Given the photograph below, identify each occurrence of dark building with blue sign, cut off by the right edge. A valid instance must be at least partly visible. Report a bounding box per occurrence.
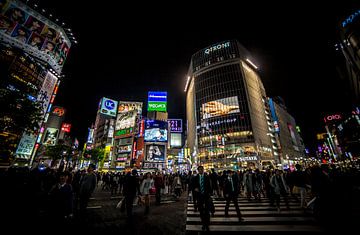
[335,8,360,105]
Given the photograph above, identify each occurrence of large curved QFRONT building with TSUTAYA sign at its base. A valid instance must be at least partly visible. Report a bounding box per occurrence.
[185,40,276,169]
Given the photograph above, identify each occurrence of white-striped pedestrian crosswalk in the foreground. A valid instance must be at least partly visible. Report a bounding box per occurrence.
[186,197,322,234]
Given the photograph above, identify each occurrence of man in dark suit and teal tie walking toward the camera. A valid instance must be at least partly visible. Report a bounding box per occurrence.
[193,166,212,231]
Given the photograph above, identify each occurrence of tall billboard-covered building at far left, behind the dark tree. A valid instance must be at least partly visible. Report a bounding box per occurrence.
[0,0,74,164]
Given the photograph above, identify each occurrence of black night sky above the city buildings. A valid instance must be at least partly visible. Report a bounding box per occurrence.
[33,0,358,151]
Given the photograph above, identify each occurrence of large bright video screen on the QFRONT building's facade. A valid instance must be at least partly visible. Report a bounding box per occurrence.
[202,96,240,119]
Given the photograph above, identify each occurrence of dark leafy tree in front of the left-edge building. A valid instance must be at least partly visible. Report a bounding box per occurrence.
[0,87,44,165]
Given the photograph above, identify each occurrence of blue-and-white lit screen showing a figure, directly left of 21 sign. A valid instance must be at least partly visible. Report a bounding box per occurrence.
[144,120,168,142]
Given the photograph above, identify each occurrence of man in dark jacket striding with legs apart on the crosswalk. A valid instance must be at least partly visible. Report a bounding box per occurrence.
[224,170,244,222]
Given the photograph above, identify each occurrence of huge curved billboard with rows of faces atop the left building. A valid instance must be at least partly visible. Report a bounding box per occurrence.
[0,0,71,74]
